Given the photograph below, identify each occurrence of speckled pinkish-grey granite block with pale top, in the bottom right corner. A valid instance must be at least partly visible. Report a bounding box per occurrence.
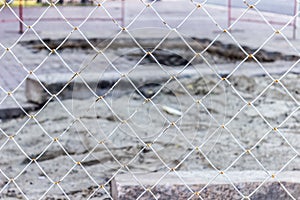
[111,171,300,200]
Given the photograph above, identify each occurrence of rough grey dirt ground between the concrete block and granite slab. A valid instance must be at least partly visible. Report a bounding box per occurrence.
[0,60,300,199]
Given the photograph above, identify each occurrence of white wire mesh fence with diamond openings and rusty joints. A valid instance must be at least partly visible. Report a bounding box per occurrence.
[0,0,300,199]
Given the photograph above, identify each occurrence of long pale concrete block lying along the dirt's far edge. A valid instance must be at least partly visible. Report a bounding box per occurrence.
[25,68,195,104]
